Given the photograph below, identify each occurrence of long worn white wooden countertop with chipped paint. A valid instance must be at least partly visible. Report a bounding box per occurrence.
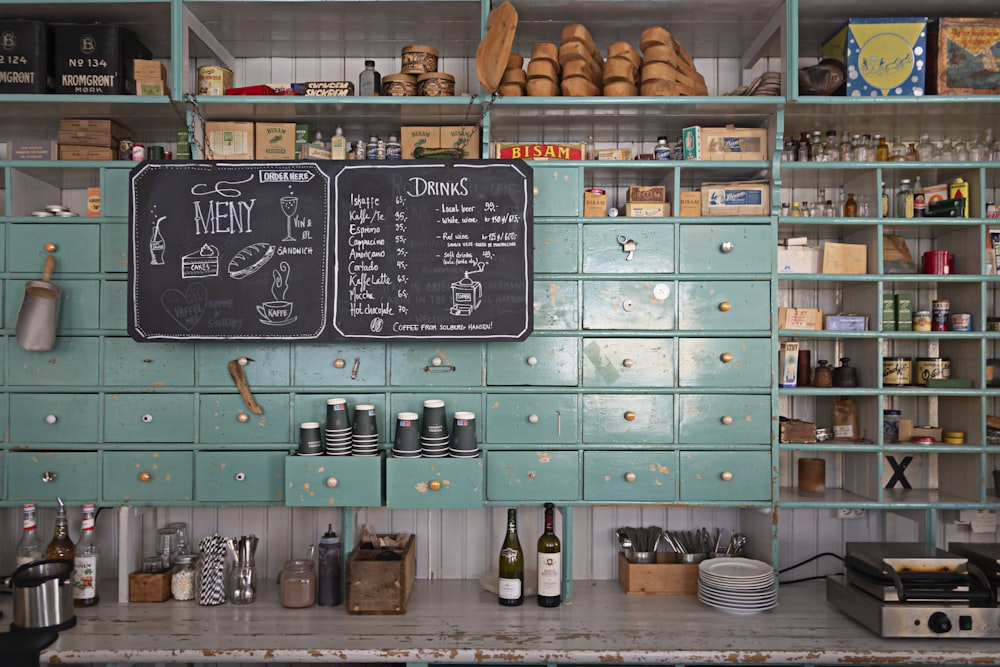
[7,581,1000,665]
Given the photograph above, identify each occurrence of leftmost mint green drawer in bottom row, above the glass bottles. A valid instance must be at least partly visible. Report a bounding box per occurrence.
[6,452,101,503]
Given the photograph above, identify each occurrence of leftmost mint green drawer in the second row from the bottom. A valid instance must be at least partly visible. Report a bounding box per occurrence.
[10,394,100,445]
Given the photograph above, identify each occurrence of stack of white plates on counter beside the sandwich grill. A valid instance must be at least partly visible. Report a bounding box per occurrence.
[698,558,778,614]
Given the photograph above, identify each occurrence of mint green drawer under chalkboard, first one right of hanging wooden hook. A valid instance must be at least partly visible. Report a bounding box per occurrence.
[292,343,385,389]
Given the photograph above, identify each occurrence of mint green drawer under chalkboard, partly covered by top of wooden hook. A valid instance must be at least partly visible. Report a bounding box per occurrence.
[195,342,292,390]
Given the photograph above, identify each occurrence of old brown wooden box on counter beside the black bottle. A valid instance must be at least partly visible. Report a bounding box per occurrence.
[346,535,416,614]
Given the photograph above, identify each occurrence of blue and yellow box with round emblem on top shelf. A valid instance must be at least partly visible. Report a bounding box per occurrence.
[822,17,927,97]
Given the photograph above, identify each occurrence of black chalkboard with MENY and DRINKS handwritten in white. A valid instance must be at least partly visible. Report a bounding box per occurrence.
[129,160,533,341]
